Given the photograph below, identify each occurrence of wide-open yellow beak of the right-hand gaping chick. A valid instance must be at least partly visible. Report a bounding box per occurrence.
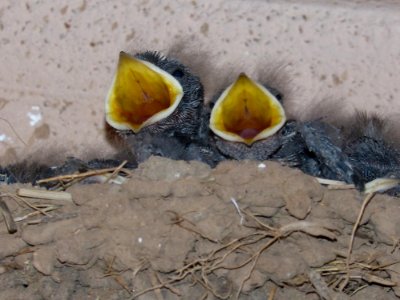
[210,73,286,145]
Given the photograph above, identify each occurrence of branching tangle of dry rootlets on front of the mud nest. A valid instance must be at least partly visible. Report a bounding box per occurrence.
[130,203,336,299]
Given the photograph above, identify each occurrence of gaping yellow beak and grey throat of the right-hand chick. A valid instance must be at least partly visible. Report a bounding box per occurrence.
[209,73,286,160]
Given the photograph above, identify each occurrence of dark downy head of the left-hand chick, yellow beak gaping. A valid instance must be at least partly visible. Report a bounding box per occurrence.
[105,51,203,135]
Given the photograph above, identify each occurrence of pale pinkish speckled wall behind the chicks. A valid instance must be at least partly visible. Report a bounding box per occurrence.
[0,0,400,162]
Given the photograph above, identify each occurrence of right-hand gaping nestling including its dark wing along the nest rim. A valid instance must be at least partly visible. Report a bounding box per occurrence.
[206,74,372,189]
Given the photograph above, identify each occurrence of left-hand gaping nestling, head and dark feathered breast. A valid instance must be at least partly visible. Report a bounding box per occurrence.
[105,51,222,165]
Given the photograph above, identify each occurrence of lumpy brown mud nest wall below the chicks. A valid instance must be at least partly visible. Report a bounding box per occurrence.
[0,158,400,299]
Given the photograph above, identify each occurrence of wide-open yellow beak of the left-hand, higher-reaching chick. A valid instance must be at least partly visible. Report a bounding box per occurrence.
[106,52,183,133]
